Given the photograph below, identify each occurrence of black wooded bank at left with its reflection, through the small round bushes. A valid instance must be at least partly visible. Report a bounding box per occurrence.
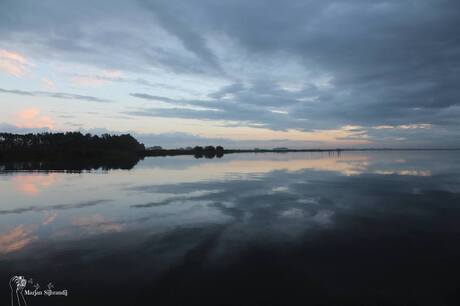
[0,132,224,172]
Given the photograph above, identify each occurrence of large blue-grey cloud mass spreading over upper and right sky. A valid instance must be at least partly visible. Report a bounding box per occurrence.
[0,0,460,145]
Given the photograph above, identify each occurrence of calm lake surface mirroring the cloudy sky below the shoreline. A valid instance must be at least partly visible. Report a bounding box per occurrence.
[0,151,460,306]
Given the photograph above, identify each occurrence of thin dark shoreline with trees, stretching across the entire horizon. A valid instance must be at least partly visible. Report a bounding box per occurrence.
[0,132,460,167]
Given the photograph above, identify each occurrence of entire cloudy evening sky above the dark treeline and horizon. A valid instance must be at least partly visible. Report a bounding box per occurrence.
[0,0,460,148]
